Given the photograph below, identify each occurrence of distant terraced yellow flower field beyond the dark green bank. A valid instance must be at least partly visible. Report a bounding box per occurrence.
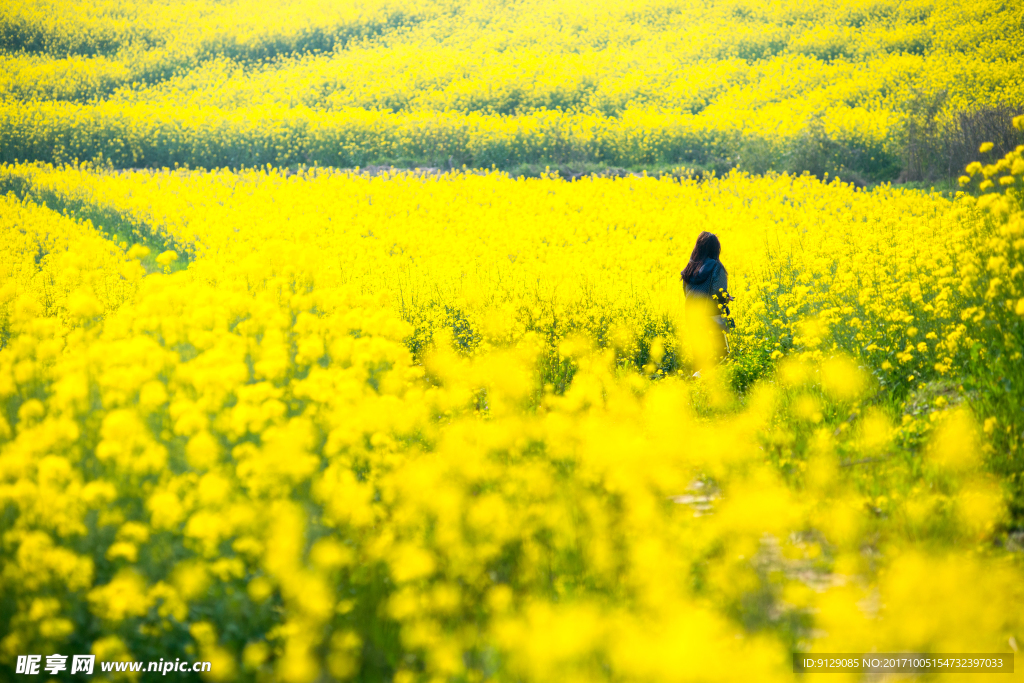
[0,0,1024,182]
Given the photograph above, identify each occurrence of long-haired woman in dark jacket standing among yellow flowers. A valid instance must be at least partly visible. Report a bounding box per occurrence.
[679,231,733,377]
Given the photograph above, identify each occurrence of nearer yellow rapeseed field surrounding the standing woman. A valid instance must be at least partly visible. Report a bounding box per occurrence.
[0,131,1024,683]
